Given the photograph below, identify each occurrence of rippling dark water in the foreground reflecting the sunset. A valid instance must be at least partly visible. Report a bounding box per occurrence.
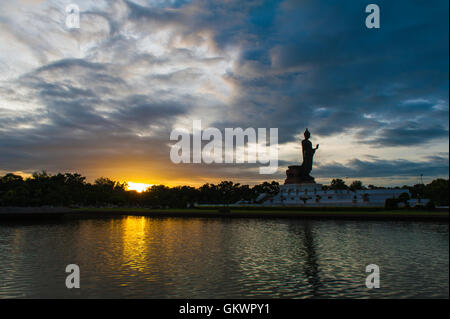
[0,217,449,298]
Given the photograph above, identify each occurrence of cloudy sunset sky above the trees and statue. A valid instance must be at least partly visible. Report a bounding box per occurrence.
[0,0,449,186]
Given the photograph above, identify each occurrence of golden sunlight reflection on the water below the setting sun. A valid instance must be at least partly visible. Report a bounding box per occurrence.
[116,216,226,295]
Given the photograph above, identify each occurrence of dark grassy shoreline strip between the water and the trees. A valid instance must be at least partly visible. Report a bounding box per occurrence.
[0,207,449,221]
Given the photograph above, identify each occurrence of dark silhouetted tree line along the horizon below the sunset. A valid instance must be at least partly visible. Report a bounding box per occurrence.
[0,171,449,208]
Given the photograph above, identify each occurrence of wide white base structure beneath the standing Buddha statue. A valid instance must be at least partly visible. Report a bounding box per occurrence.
[262,183,416,206]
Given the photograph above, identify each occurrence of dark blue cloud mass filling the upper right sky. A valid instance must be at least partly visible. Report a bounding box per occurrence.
[215,1,448,145]
